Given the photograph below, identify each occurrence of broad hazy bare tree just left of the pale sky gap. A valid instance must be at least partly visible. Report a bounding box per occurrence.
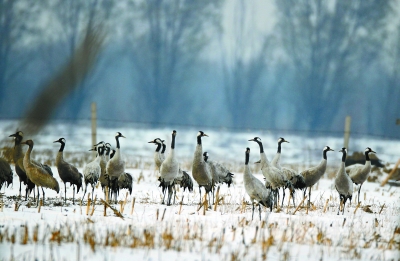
[127,0,221,123]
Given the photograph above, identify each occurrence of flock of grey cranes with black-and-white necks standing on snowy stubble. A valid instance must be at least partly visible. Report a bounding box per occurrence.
[0,130,375,219]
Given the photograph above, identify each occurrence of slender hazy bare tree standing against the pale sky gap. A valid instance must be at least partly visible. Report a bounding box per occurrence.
[220,0,274,128]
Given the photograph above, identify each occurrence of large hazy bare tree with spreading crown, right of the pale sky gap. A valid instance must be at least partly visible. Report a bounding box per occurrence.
[276,0,390,129]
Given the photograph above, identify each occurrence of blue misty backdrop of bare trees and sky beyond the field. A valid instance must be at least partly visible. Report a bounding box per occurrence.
[0,0,400,138]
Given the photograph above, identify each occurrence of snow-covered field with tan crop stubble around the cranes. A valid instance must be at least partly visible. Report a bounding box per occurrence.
[0,121,400,260]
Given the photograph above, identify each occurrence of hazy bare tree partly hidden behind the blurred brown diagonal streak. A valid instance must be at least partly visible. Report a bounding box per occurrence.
[43,0,113,118]
